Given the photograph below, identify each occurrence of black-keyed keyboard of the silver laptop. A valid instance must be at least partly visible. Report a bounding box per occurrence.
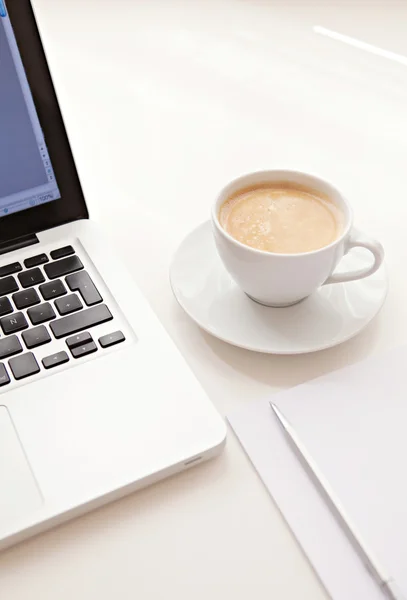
[0,246,125,387]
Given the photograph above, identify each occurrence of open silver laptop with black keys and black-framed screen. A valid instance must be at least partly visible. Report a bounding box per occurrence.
[0,0,226,549]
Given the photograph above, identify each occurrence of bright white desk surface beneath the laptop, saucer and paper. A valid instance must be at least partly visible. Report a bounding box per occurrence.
[0,0,407,600]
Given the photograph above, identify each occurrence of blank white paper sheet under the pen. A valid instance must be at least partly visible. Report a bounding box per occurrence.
[229,347,407,600]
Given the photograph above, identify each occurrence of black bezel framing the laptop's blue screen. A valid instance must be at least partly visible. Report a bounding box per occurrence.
[0,0,89,243]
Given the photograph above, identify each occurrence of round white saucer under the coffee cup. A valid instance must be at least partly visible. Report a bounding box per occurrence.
[170,222,388,354]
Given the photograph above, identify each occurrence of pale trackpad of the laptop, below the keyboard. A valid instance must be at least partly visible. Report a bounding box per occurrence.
[0,406,42,530]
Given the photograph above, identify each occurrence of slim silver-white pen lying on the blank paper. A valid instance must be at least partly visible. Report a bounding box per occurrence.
[270,402,404,600]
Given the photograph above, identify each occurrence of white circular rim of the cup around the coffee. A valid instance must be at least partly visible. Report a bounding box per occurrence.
[211,168,353,258]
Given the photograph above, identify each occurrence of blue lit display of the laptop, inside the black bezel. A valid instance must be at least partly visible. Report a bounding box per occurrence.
[0,0,61,217]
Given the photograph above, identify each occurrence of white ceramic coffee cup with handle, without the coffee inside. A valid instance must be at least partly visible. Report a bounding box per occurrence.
[212,170,384,306]
